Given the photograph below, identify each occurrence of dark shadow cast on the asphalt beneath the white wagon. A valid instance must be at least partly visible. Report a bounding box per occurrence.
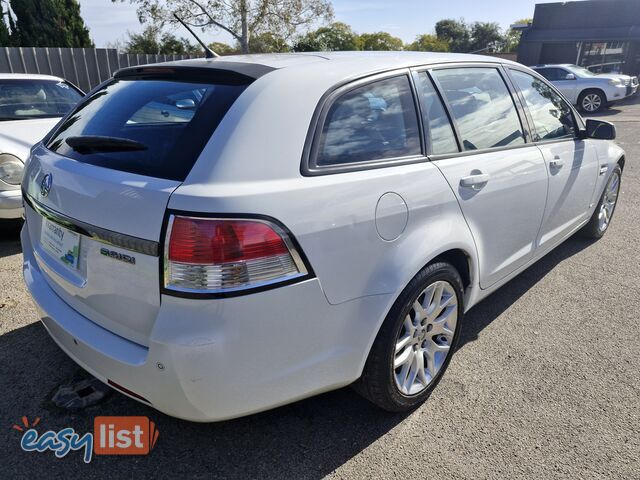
[0,232,590,479]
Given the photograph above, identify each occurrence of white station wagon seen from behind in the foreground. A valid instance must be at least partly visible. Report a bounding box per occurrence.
[22,53,625,421]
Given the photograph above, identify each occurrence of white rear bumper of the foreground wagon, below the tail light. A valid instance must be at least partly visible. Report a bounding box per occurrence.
[22,226,392,422]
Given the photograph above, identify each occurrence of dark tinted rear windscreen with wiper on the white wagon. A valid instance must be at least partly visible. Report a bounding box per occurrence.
[47,78,247,181]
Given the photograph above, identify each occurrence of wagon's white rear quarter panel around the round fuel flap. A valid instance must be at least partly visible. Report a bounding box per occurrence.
[170,161,476,304]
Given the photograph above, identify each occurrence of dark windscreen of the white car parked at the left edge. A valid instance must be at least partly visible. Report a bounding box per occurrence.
[0,79,82,120]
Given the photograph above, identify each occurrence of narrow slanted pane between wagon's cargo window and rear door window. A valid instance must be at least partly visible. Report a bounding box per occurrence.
[418,72,458,155]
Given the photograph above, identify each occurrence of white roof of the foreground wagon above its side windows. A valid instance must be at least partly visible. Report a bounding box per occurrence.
[132,51,516,78]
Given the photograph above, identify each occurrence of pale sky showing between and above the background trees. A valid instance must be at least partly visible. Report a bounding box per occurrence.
[79,0,557,47]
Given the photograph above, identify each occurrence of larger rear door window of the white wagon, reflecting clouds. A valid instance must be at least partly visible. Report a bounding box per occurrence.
[433,68,524,150]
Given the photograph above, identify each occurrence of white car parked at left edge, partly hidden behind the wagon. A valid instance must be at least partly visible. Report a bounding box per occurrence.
[0,73,83,219]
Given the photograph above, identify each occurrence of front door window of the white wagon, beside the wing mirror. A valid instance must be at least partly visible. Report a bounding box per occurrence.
[511,70,576,141]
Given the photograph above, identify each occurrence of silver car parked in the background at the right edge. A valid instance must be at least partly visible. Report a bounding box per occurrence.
[532,64,638,113]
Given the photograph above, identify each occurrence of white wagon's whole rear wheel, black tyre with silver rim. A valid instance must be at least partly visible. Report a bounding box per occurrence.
[354,262,464,412]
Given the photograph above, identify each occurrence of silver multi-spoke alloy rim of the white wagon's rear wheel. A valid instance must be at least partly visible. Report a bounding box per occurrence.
[393,281,458,395]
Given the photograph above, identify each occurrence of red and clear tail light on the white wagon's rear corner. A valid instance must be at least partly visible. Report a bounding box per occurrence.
[164,215,308,294]
